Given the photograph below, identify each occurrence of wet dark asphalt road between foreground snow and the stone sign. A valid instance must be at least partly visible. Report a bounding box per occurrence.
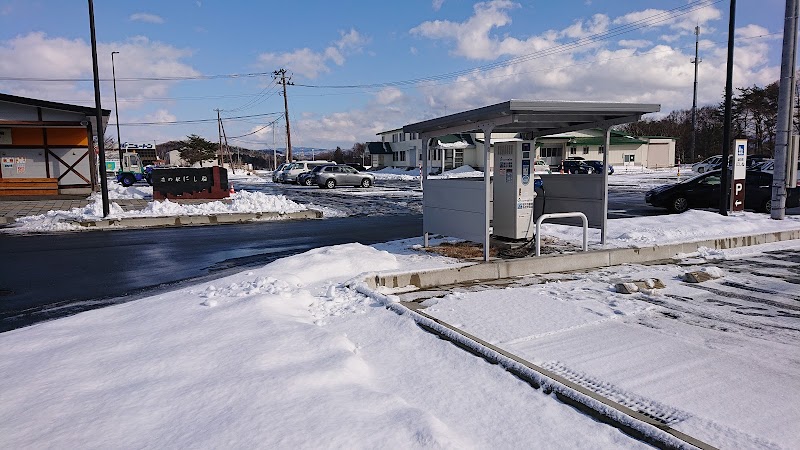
[0,215,422,332]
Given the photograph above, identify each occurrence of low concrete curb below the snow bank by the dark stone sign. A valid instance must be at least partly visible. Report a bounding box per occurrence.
[72,209,322,229]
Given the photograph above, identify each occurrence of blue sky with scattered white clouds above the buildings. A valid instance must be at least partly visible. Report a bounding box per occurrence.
[0,0,785,148]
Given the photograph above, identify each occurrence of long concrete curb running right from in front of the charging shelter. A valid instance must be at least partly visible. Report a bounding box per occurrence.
[364,229,800,289]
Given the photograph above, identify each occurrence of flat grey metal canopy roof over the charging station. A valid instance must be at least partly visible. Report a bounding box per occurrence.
[403,100,661,138]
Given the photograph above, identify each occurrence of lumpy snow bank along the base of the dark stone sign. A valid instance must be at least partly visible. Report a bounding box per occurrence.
[6,191,308,233]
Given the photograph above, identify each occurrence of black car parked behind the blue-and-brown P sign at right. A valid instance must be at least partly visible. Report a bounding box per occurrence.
[644,170,800,213]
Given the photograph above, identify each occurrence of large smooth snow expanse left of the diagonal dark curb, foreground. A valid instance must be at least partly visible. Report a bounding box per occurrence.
[0,244,646,448]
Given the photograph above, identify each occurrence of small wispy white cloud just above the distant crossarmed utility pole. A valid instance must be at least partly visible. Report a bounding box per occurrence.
[258,28,369,79]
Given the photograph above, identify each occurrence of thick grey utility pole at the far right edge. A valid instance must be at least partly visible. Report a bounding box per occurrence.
[770,0,798,220]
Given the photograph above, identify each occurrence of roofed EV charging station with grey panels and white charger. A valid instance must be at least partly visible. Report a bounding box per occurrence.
[403,100,661,261]
